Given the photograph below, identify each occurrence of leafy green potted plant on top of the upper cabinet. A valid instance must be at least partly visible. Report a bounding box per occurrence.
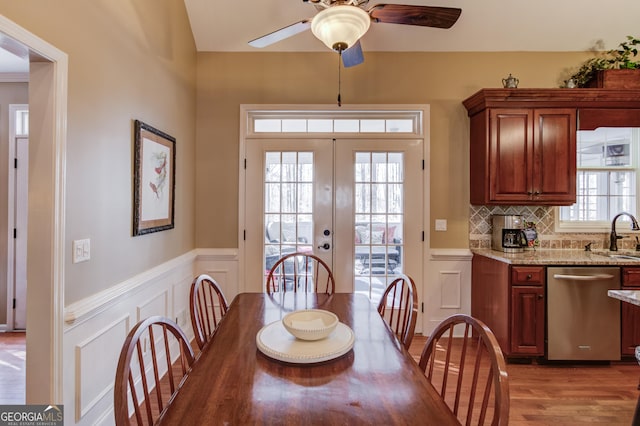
[570,36,640,89]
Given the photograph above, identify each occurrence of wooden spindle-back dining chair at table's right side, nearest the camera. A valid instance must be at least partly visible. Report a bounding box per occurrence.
[419,314,509,426]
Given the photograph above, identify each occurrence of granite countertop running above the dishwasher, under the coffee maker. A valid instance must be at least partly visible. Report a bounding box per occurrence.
[471,249,640,266]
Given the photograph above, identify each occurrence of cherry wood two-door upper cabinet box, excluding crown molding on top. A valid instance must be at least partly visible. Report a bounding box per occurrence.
[465,89,576,205]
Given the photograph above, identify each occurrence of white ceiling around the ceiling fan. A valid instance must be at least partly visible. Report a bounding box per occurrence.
[185,0,640,52]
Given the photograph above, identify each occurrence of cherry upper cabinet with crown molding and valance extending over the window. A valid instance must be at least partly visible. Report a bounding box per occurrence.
[463,89,640,206]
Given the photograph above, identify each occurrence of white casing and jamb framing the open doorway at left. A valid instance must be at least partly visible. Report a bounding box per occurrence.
[0,15,68,404]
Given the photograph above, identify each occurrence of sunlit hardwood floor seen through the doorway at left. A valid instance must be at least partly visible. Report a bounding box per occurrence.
[0,333,26,404]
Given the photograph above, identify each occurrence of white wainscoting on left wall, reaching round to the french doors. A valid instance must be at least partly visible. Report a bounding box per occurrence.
[63,249,240,425]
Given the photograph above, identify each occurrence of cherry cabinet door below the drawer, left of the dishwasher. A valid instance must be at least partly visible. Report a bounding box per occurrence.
[511,286,544,355]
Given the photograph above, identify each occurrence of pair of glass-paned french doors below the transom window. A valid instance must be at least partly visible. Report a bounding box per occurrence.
[244,138,424,303]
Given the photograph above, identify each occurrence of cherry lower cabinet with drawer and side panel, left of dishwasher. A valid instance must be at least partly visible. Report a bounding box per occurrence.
[471,255,545,357]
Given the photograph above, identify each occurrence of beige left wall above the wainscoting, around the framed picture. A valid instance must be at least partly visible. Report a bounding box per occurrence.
[0,0,196,304]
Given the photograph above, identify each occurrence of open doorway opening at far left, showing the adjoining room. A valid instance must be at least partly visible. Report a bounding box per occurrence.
[0,65,29,404]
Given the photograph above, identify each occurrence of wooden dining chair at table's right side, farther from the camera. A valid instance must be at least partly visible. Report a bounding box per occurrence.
[378,275,418,350]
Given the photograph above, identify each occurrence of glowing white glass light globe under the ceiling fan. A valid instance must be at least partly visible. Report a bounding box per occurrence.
[311,5,371,49]
